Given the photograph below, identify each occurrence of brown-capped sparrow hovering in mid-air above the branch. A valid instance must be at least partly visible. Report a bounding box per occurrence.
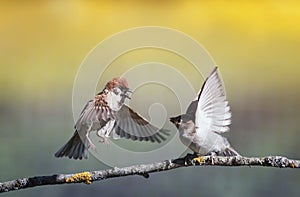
[55,78,168,159]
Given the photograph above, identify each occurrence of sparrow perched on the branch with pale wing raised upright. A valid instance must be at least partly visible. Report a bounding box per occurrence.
[170,67,239,156]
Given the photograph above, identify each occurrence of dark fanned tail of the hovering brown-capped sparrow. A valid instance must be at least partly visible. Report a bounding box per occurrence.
[54,131,88,159]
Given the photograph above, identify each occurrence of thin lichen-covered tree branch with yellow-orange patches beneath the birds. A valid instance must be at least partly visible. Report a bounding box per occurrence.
[0,155,300,193]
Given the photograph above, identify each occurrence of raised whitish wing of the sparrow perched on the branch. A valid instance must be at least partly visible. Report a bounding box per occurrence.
[193,67,231,133]
